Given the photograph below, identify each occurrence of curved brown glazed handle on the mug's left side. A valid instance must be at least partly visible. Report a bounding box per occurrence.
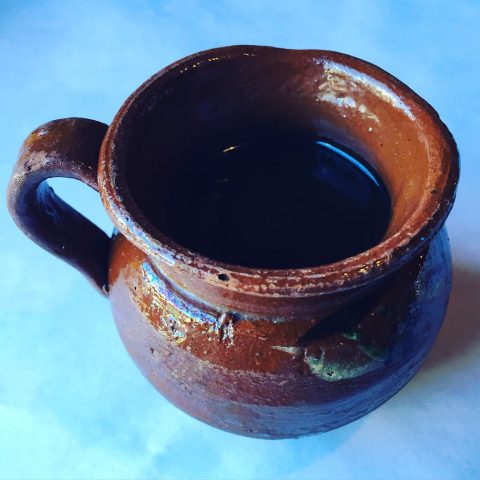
[7,118,110,295]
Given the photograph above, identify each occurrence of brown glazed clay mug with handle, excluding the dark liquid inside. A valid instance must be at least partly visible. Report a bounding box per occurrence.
[8,46,459,438]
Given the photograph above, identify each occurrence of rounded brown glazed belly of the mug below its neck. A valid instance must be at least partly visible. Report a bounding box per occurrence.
[110,229,451,438]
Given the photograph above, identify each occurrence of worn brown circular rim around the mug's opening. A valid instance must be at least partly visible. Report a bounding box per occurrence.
[98,45,459,297]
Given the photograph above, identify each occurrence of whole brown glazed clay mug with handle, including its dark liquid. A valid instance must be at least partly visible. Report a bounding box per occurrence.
[8,46,459,438]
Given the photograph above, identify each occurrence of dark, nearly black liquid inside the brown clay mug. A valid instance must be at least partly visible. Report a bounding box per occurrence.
[159,138,390,269]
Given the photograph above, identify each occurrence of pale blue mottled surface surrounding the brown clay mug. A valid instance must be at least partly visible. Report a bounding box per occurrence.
[0,0,480,479]
